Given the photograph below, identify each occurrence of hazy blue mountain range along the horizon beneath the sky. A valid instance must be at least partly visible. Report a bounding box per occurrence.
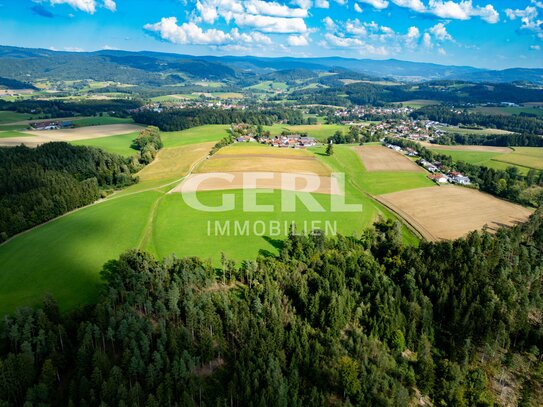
[0,46,543,85]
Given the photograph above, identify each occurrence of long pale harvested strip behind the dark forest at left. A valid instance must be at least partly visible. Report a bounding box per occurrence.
[0,124,143,147]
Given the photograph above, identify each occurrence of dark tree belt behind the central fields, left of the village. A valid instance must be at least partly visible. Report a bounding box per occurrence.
[132,108,305,131]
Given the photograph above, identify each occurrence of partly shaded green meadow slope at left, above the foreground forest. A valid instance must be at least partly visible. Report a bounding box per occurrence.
[0,192,159,315]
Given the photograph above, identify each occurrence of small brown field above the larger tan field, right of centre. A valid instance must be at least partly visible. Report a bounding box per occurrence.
[354,146,424,172]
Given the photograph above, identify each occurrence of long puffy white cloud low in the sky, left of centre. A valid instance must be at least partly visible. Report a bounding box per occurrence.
[144,17,272,45]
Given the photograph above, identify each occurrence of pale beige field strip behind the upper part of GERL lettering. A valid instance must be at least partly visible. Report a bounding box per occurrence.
[170,172,342,195]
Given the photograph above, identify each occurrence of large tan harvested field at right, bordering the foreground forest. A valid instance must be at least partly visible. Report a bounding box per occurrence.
[376,186,532,241]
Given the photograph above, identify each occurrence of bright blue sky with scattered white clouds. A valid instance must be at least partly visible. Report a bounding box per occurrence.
[0,0,543,69]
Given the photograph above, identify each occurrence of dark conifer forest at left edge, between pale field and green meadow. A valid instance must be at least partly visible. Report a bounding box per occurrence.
[0,142,138,242]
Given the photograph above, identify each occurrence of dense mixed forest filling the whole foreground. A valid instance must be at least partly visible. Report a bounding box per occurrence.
[0,211,543,407]
